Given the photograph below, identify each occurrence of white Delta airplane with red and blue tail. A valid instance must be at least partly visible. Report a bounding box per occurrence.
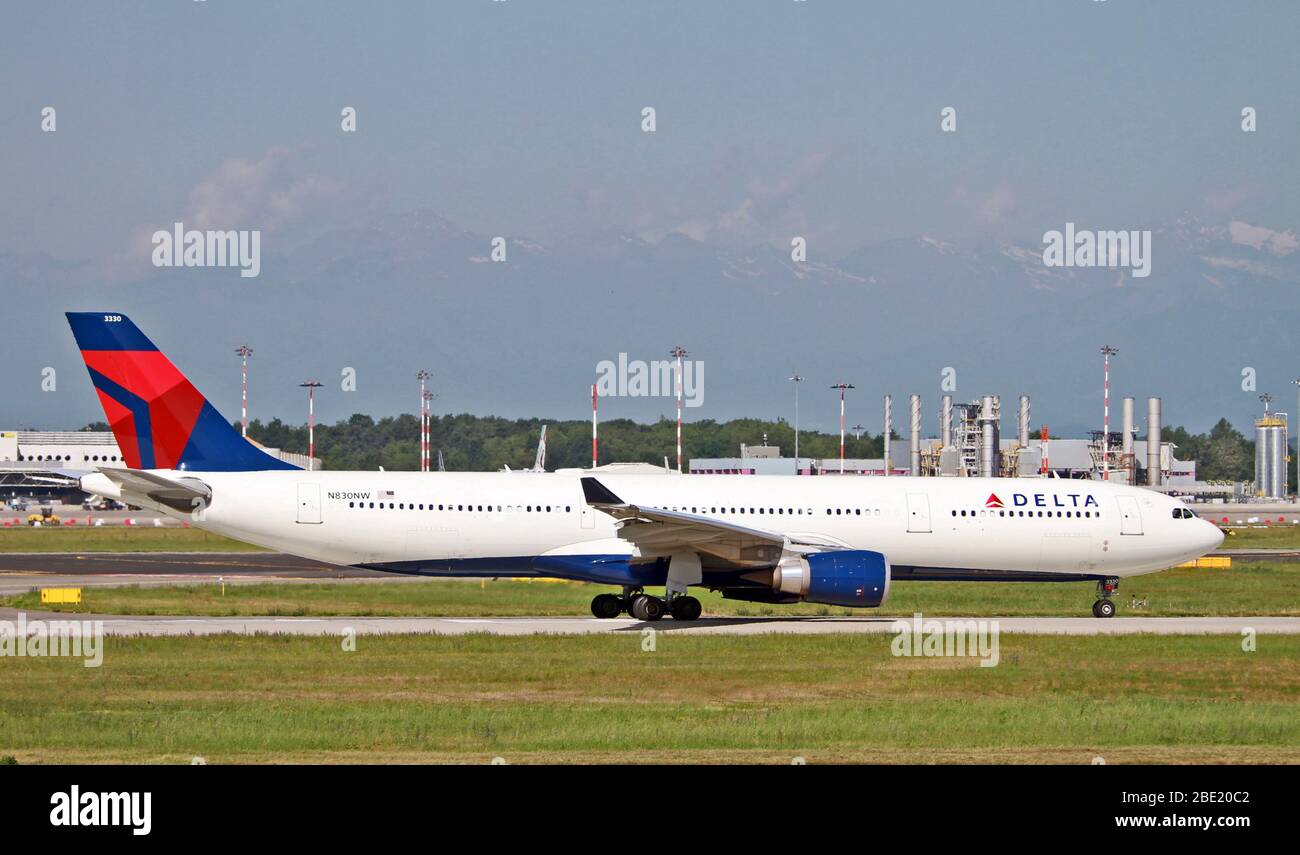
[68,312,1223,621]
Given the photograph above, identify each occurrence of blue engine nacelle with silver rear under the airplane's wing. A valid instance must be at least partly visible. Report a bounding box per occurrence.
[772,550,889,608]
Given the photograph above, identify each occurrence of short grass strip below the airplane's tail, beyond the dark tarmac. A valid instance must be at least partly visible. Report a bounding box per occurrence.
[0,525,263,552]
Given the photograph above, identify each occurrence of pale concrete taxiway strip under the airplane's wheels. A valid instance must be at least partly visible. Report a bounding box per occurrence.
[0,608,1300,637]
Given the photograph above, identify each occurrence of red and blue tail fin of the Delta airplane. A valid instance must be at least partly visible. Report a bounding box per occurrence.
[68,312,295,472]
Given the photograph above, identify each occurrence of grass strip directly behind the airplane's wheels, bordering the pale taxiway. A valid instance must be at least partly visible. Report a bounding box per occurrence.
[10,561,1300,617]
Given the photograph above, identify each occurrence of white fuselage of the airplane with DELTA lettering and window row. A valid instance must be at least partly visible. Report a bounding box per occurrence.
[83,472,1222,577]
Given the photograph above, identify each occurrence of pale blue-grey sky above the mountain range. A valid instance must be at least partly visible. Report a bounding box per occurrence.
[0,0,1300,436]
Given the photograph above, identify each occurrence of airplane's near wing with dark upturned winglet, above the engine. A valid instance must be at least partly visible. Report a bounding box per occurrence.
[582,477,844,568]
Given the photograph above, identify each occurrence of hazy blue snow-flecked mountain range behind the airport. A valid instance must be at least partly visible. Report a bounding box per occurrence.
[0,209,1300,434]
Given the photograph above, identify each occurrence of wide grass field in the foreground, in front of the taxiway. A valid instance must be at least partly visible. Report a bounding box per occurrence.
[0,633,1300,764]
